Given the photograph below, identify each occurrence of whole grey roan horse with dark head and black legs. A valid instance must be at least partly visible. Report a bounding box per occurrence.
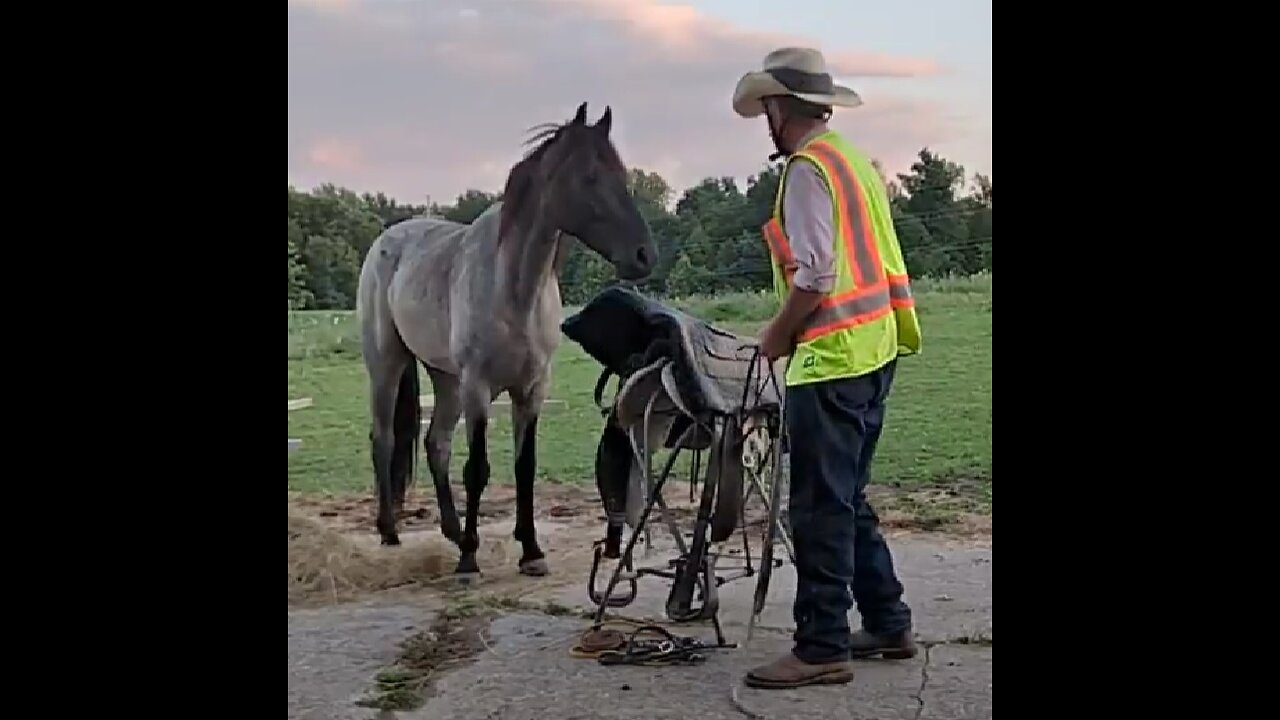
[356,102,658,575]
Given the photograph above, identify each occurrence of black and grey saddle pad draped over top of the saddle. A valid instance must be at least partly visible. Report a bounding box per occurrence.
[561,286,782,419]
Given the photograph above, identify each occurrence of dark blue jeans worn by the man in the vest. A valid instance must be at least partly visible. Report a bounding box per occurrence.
[786,360,911,662]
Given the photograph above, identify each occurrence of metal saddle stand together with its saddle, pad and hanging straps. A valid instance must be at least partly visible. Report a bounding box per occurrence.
[562,287,794,648]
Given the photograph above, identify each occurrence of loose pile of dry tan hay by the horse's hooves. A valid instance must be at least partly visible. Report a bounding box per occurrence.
[289,503,511,605]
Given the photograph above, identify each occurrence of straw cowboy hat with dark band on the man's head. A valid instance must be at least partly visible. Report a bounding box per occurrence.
[733,47,863,118]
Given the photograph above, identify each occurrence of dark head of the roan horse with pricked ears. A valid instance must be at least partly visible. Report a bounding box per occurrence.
[500,102,658,281]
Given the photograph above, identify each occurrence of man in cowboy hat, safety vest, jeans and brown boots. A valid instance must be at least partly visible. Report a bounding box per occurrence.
[733,47,920,688]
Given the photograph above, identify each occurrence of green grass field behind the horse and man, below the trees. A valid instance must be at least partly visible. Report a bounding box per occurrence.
[289,275,992,511]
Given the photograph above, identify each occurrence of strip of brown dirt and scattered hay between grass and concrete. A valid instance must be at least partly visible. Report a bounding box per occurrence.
[289,479,991,606]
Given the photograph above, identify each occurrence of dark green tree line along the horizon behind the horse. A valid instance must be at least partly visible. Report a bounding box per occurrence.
[289,149,991,310]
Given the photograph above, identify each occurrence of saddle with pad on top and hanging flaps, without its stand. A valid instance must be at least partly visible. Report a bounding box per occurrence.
[561,287,782,542]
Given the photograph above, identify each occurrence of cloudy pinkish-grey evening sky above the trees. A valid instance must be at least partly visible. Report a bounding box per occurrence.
[289,0,991,204]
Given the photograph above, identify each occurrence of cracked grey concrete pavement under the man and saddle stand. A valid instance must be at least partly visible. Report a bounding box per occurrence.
[289,536,992,720]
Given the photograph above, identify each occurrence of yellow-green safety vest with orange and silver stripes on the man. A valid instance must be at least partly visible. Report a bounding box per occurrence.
[763,131,922,386]
